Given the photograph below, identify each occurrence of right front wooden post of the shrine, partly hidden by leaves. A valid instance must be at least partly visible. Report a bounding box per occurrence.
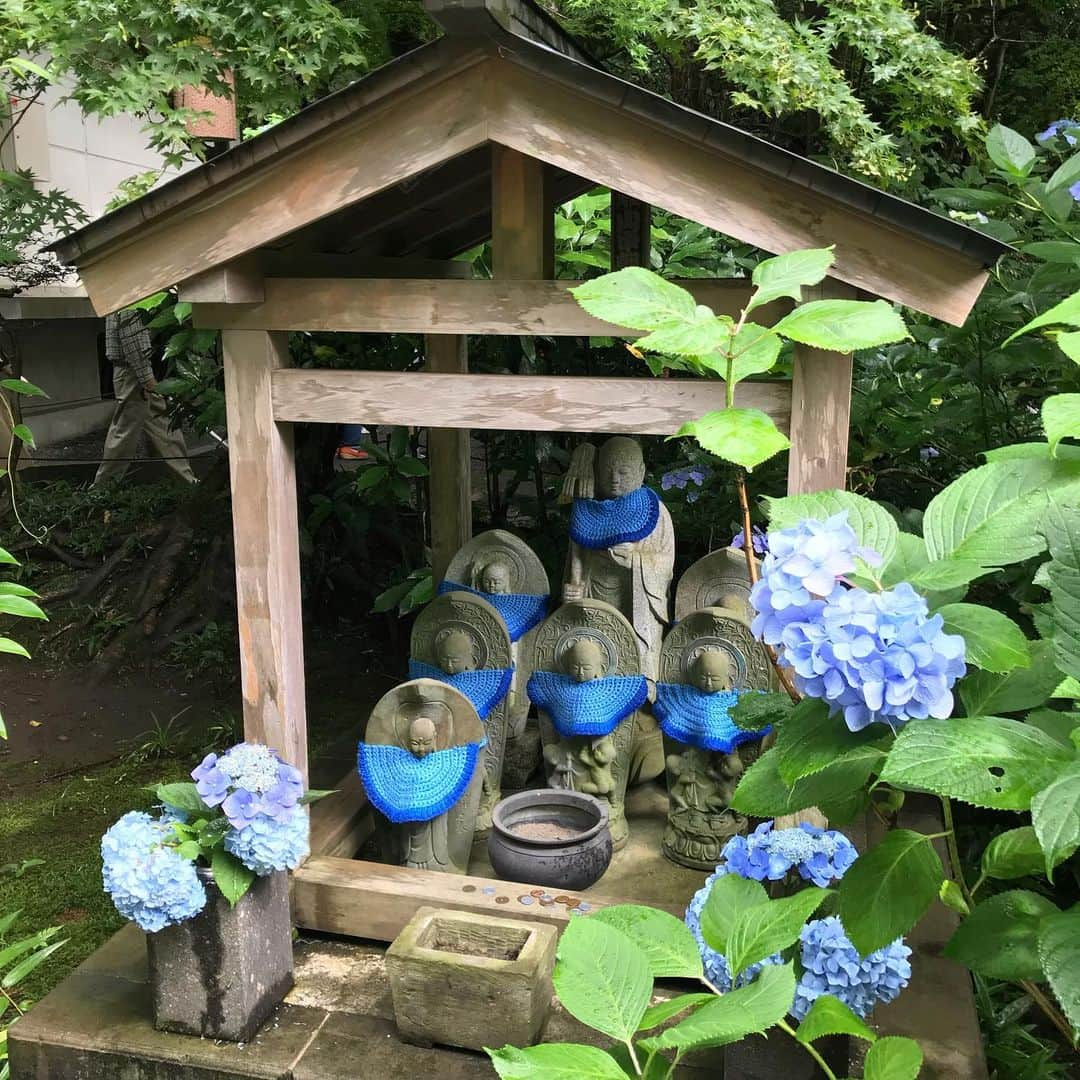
[787,281,855,495]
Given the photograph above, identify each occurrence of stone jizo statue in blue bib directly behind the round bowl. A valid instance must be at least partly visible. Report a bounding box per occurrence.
[528,600,648,850]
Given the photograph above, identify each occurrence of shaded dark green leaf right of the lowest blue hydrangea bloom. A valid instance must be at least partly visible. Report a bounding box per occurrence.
[944,889,1057,980]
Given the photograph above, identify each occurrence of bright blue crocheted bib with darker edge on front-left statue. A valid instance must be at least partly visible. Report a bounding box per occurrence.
[356,742,484,824]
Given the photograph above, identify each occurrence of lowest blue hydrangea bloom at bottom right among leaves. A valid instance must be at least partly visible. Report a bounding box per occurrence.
[792,916,912,1020]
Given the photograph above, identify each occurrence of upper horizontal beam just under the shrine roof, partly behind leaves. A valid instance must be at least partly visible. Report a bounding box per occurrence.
[193,278,791,337]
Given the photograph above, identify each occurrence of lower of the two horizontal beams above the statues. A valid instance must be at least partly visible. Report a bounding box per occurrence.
[273,367,792,435]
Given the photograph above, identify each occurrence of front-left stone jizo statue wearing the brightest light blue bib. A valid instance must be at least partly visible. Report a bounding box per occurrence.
[357,678,484,874]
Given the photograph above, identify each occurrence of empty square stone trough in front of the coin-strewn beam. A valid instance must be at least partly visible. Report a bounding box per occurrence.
[387,907,557,1050]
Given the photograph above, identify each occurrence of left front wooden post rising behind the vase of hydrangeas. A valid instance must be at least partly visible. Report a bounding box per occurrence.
[221,330,308,778]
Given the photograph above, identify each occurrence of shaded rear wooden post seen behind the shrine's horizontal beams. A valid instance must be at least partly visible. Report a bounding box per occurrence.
[423,334,472,584]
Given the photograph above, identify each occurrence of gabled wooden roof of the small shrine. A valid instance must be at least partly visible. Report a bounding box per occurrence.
[54,0,1009,324]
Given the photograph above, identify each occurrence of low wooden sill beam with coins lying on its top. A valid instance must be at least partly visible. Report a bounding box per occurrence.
[293,855,683,942]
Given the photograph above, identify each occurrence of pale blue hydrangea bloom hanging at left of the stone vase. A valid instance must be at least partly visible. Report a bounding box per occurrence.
[102,811,206,933]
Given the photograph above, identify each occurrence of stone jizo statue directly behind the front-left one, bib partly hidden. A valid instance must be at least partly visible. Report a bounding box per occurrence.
[408,592,514,835]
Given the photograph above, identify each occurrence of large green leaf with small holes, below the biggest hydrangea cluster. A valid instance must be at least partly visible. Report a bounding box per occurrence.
[881,716,1072,810]
